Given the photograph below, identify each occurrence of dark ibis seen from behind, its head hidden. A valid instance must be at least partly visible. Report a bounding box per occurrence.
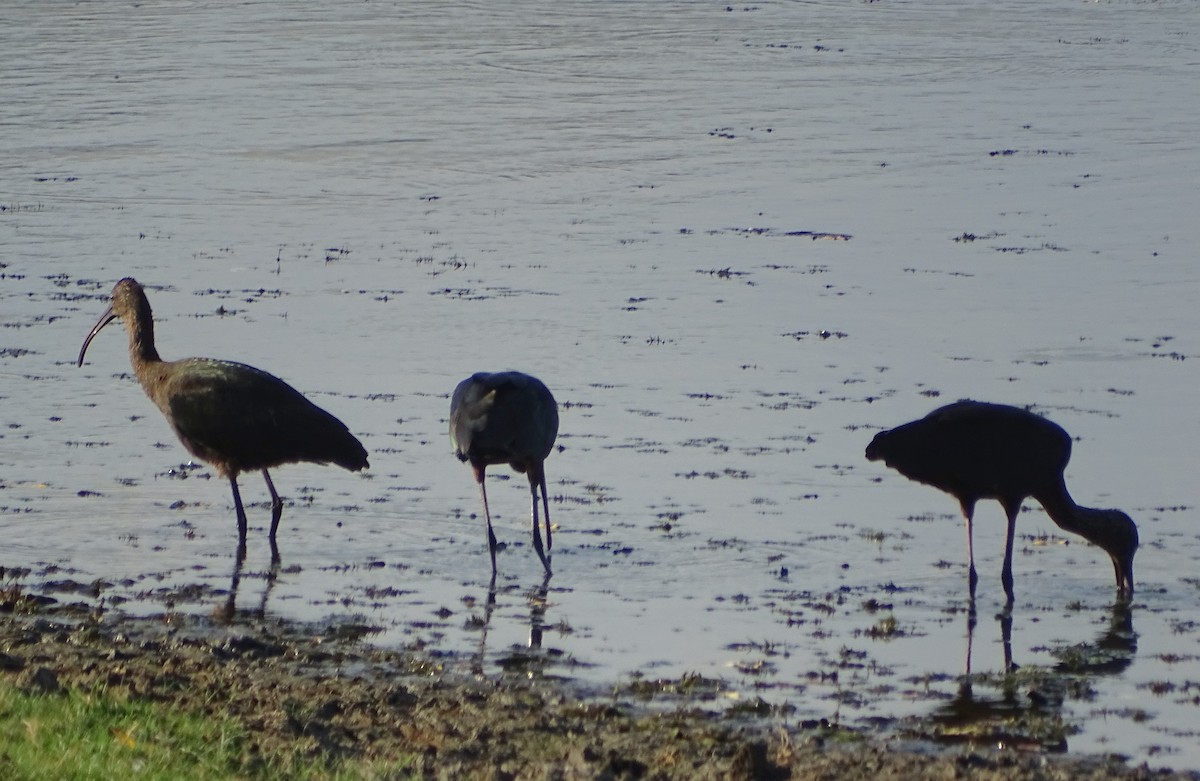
[450,372,558,576]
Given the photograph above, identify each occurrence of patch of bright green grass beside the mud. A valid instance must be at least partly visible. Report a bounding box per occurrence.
[0,680,408,781]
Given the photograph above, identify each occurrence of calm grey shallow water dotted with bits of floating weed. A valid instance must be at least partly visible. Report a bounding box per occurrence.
[0,0,1200,768]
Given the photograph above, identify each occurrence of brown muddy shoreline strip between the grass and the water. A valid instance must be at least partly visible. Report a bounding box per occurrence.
[0,584,1200,781]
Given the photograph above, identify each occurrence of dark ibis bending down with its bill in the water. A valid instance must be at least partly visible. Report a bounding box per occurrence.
[866,401,1138,605]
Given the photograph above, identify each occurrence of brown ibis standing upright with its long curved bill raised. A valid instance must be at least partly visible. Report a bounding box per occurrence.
[79,278,368,561]
